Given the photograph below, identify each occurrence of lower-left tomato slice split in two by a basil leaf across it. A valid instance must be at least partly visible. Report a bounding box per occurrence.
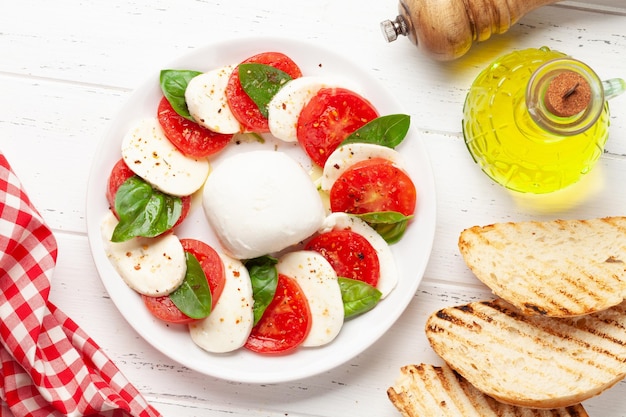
[141,239,226,324]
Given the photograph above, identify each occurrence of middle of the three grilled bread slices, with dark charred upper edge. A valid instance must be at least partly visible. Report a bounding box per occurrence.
[426,299,626,408]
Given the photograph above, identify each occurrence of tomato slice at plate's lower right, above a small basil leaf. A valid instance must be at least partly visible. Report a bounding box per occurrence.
[306,230,380,287]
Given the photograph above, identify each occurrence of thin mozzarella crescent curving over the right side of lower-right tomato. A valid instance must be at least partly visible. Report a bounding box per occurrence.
[320,213,398,299]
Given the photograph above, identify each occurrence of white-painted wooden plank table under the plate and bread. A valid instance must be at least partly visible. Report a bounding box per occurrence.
[0,0,626,417]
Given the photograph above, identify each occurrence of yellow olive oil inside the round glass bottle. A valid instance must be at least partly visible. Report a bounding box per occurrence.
[463,47,609,194]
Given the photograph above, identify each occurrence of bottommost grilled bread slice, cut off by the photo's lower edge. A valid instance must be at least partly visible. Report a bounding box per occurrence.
[387,364,588,417]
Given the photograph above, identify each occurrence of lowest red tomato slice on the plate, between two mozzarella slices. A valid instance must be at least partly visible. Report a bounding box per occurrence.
[245,274,311,354]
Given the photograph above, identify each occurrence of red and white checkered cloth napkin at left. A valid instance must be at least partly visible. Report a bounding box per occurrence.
[0,153,160,417]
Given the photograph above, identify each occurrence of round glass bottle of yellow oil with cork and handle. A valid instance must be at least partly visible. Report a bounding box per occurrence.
[463,47,626,194]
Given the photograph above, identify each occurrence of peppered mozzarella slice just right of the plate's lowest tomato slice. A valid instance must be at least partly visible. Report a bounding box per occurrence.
[276,250,344,346]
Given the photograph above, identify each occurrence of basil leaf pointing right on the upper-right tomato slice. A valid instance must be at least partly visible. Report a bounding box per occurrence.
[341,114,411,149]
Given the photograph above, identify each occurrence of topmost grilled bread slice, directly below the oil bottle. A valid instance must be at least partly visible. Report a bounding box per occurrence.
[459,217,626,317]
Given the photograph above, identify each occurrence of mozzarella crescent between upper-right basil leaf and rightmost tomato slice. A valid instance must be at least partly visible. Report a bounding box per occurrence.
[320,143,405,191]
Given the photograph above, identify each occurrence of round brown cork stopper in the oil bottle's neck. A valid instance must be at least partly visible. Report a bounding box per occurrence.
[544,71,591,117]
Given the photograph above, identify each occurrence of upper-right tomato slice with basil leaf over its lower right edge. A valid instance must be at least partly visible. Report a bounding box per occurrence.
[297,88,378,167]
